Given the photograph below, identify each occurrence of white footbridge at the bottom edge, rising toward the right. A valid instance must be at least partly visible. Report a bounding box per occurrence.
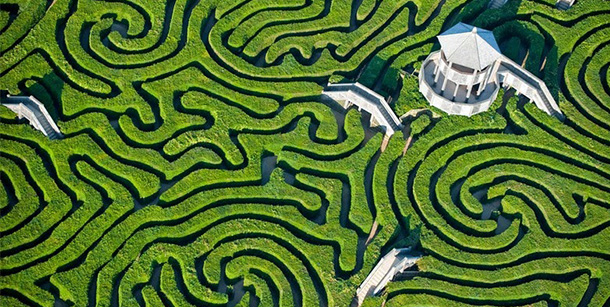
[356,247,421,306]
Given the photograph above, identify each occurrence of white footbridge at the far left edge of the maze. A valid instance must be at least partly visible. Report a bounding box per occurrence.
[0,95,63,140]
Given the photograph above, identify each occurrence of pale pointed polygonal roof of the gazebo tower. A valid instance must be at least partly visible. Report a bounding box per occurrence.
[437,22,502,70]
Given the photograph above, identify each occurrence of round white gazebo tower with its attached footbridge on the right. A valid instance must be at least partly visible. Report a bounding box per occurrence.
[419,23,563,119]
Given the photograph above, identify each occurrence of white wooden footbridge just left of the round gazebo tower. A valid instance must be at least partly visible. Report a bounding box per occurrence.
[322,82,403,150]
